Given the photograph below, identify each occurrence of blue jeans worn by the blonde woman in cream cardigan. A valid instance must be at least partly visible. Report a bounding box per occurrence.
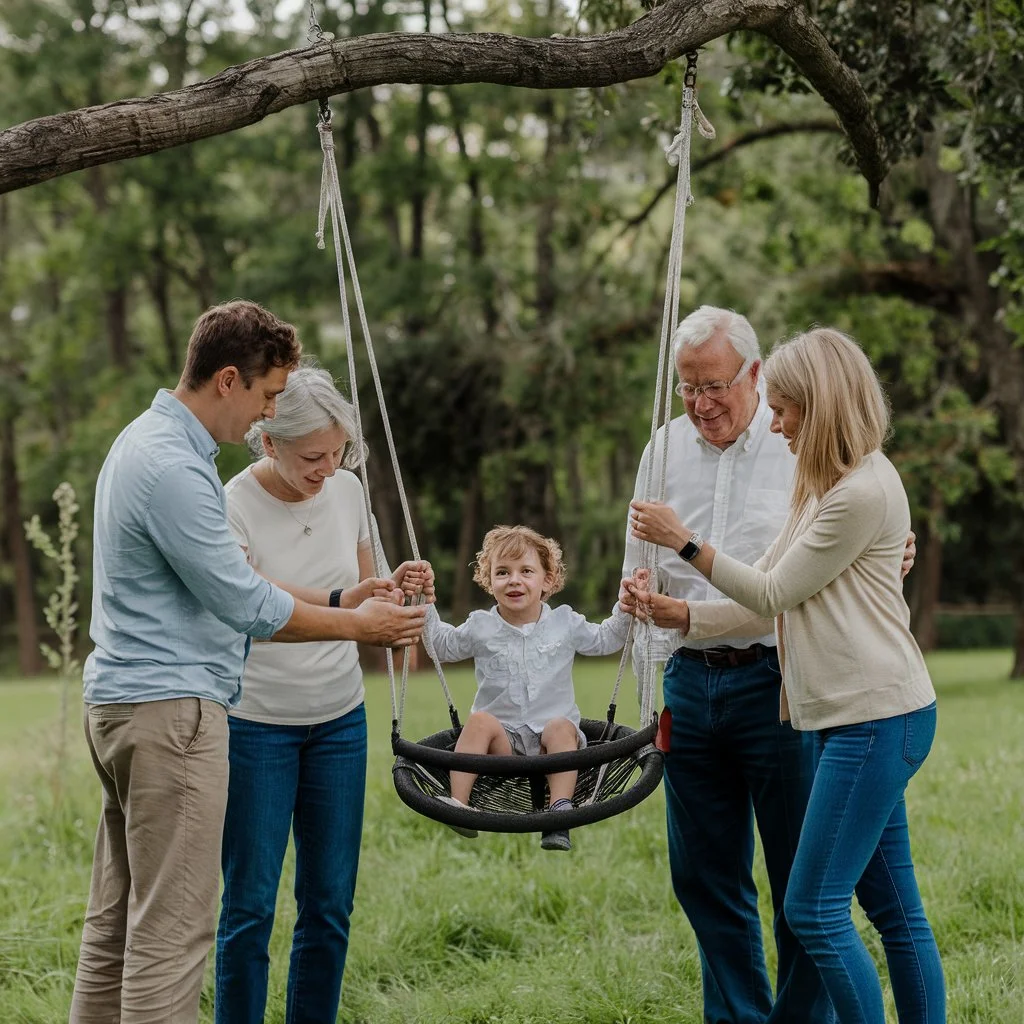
[785,703,946,1024]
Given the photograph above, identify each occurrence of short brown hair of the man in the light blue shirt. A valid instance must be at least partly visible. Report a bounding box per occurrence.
[182,299,302,391]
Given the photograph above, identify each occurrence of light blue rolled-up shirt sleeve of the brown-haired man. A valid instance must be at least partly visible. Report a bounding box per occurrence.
[146,465,295,639]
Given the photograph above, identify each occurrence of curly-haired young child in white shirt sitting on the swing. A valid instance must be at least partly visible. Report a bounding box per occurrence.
[426,526,630,850]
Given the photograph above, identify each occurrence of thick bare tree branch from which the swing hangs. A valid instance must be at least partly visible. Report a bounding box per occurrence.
[0,0,888,195]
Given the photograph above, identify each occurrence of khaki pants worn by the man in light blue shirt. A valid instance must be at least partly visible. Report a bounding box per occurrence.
[71,697,227,1024]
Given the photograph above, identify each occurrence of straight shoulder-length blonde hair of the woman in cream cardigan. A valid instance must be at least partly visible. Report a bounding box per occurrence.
[764,327,889,511]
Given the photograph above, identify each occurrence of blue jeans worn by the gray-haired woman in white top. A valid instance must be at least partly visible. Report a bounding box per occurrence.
[216,705,367,1024]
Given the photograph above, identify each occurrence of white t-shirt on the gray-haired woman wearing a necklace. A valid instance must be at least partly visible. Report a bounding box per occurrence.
[224,466,370,725]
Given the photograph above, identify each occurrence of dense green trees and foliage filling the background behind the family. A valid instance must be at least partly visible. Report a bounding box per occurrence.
[0,0,1024,669]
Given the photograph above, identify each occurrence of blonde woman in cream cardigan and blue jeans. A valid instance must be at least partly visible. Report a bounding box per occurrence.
[624,329,945,1024]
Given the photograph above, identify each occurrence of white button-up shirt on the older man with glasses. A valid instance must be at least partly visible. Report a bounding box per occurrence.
[623,392,797,660]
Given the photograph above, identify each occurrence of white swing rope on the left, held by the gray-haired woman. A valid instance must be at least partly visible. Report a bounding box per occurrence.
[316,117,453,733]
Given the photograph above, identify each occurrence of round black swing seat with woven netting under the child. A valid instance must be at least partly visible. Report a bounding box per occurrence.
[391,718,664,833]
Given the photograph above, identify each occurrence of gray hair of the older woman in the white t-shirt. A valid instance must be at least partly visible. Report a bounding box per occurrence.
[246,358,367,469]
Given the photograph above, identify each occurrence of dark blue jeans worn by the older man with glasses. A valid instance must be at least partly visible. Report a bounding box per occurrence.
[665,651,835,1024]
